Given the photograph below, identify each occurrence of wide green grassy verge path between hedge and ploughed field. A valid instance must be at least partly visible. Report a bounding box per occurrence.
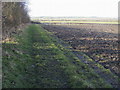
[2,25,117,88]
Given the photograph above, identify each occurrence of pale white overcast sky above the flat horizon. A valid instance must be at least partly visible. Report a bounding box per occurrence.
[29,0,120,18]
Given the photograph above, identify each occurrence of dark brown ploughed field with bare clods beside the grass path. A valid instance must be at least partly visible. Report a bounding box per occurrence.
[42,23,120,75]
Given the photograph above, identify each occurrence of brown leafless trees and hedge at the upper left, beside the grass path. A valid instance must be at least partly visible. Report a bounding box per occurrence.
[2,2,30,38]
